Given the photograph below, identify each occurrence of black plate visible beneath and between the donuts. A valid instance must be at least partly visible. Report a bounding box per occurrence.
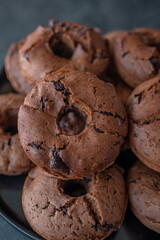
[0,70,160,240]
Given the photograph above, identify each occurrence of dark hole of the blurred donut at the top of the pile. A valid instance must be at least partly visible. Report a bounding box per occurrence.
[51,40,74,59]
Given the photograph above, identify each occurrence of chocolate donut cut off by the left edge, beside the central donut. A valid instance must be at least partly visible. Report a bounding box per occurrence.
[0,93,33,175]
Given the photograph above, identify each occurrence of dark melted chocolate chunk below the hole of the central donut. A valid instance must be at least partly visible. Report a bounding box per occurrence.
[50,147,70,173]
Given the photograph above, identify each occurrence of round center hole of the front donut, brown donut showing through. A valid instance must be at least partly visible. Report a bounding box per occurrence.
[58,106,86,135]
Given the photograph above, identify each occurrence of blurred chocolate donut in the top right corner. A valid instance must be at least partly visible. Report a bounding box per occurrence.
[112,28,160,88]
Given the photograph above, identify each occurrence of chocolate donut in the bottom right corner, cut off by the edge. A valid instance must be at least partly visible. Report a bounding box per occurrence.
[127,161,160,233]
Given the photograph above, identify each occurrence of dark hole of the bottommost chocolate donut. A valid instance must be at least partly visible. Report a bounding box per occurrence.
[63,179,87,197]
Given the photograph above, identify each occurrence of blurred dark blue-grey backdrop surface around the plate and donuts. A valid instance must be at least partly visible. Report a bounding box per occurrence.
[0,0,160,240]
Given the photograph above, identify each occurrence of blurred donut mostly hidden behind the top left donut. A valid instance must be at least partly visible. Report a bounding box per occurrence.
[5,42,32,94]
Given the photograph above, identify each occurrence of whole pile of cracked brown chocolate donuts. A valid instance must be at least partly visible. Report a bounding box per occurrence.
[0,18,160,240]
